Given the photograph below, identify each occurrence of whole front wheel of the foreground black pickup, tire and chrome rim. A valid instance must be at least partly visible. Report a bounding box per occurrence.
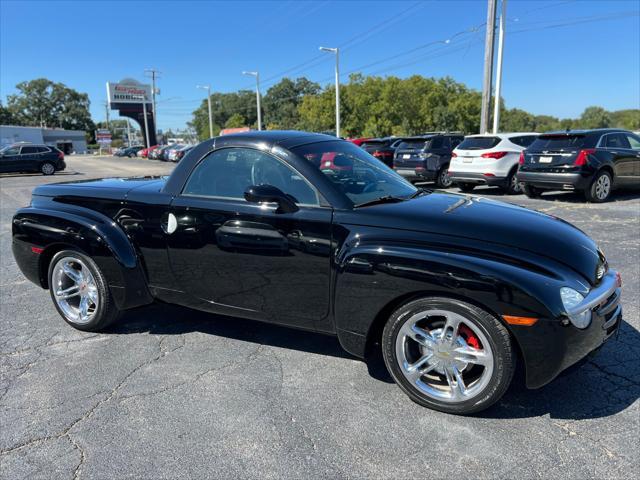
[382,297,516,415]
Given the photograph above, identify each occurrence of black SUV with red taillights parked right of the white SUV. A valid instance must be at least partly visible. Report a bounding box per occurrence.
[518,129,640,202]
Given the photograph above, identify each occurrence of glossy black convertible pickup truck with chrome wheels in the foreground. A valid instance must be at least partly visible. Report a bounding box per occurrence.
[13,131,622,414]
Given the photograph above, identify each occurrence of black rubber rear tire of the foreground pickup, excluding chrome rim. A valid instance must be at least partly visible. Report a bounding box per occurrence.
[47,249,117,332]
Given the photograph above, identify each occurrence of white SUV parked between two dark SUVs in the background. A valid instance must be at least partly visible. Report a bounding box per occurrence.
[449,132,538,194]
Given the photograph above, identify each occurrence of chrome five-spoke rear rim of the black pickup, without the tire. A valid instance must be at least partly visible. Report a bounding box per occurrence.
[50,257,100,325]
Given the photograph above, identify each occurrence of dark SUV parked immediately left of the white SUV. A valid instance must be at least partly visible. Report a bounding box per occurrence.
[393,133,464,188]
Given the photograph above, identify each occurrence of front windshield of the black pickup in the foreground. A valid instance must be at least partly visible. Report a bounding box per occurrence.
[291,141,418,205]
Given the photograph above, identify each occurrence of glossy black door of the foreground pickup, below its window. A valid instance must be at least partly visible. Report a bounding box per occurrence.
[167,196,332,329]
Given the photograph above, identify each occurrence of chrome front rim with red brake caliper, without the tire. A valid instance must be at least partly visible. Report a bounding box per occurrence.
[395,310,494,403]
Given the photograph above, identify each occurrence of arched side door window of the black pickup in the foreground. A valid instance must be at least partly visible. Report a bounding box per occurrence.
[182,148,320,205]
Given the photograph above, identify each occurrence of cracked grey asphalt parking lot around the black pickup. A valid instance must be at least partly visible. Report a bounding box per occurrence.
[0,157,640,479]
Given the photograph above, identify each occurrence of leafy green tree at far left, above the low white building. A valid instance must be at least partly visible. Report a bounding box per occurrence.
[7,78,94,133]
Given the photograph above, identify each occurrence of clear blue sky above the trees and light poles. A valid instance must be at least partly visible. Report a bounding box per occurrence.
[0,0,640,129]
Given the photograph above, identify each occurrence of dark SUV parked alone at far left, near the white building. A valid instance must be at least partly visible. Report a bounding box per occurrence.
[0,143,67,175]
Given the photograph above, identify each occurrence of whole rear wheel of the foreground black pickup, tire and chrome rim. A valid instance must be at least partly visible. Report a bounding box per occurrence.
[48,250,120,332]
